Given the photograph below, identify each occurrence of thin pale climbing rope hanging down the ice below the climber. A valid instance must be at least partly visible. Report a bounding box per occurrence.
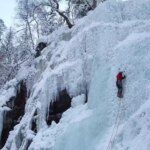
[106,101,122,150]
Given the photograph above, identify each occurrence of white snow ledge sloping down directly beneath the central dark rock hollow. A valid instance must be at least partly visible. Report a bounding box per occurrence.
[29,105,92,150]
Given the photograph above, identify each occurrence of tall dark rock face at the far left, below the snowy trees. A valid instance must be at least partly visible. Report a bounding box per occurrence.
[0,81,27,148]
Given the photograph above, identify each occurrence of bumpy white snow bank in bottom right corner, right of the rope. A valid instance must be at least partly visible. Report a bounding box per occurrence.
[110,100,150,150]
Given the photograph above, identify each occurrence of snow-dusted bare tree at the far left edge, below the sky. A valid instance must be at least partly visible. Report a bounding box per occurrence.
[0,28,31,87]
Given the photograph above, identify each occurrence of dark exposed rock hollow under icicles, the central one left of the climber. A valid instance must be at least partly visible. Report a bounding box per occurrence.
[47,89,72,125]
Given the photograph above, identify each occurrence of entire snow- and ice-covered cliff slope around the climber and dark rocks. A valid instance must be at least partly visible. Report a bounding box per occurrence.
[0,0,150,150]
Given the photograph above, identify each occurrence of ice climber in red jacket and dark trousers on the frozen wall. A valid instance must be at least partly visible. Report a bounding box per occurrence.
[116,71,126,98]
